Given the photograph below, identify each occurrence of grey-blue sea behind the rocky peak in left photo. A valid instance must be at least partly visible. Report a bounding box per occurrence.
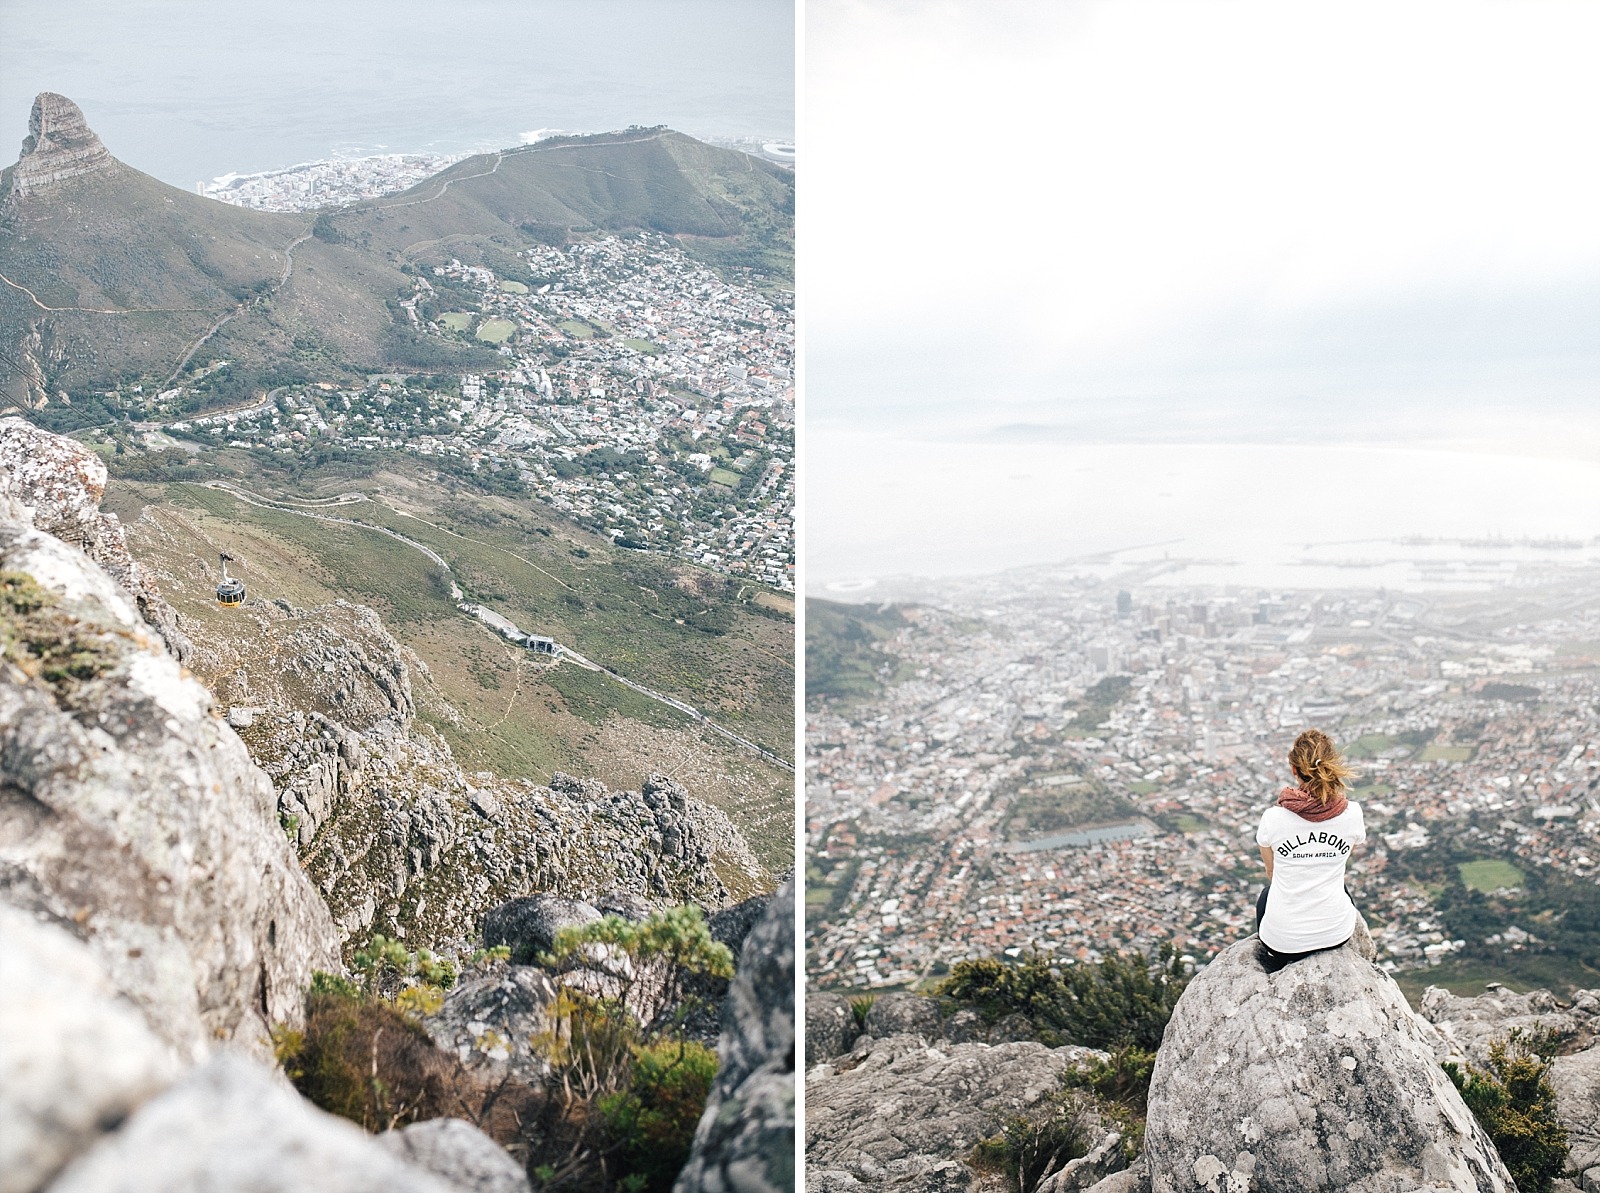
[0,0,795,190]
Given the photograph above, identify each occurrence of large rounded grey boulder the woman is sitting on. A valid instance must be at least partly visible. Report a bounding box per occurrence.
[1144,928,1512,1193]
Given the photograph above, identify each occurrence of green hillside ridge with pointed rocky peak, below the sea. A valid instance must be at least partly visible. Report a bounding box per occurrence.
[0,93,794,406]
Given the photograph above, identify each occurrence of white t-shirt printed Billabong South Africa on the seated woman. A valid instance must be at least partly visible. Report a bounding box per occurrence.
[1256,803,1366,953]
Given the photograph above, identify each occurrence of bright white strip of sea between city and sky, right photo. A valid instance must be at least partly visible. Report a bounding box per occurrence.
[805,430,1600,600]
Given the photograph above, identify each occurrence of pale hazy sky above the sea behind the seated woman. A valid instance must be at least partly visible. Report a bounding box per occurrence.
[802,0,1600,454]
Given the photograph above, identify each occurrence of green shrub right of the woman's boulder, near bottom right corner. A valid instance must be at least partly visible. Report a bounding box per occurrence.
[1445,1028,1566,1193]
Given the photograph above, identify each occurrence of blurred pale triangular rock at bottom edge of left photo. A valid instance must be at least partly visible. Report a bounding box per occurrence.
[50,1052,459,1193]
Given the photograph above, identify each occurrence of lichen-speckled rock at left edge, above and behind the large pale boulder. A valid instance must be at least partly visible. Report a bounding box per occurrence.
[0,415,194,662]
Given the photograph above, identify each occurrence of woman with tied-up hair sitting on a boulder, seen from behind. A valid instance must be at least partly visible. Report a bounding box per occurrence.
[1256,729,1366,971]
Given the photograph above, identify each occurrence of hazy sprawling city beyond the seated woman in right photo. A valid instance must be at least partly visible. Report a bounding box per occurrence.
[806,569,1600,988]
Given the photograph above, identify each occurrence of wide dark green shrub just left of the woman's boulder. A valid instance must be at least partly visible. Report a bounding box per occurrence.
[939,945,1192,1052]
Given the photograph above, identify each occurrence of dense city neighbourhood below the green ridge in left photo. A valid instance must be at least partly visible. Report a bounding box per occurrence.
[164,233,795,590]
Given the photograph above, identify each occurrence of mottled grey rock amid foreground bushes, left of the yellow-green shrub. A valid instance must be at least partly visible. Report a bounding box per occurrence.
[422,966,557,1081]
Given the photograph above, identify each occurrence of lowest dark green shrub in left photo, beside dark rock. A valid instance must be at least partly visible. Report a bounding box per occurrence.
[597,1039,717,1193]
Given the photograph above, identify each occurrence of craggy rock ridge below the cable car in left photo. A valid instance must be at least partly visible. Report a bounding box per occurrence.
[175,582,773,953]
